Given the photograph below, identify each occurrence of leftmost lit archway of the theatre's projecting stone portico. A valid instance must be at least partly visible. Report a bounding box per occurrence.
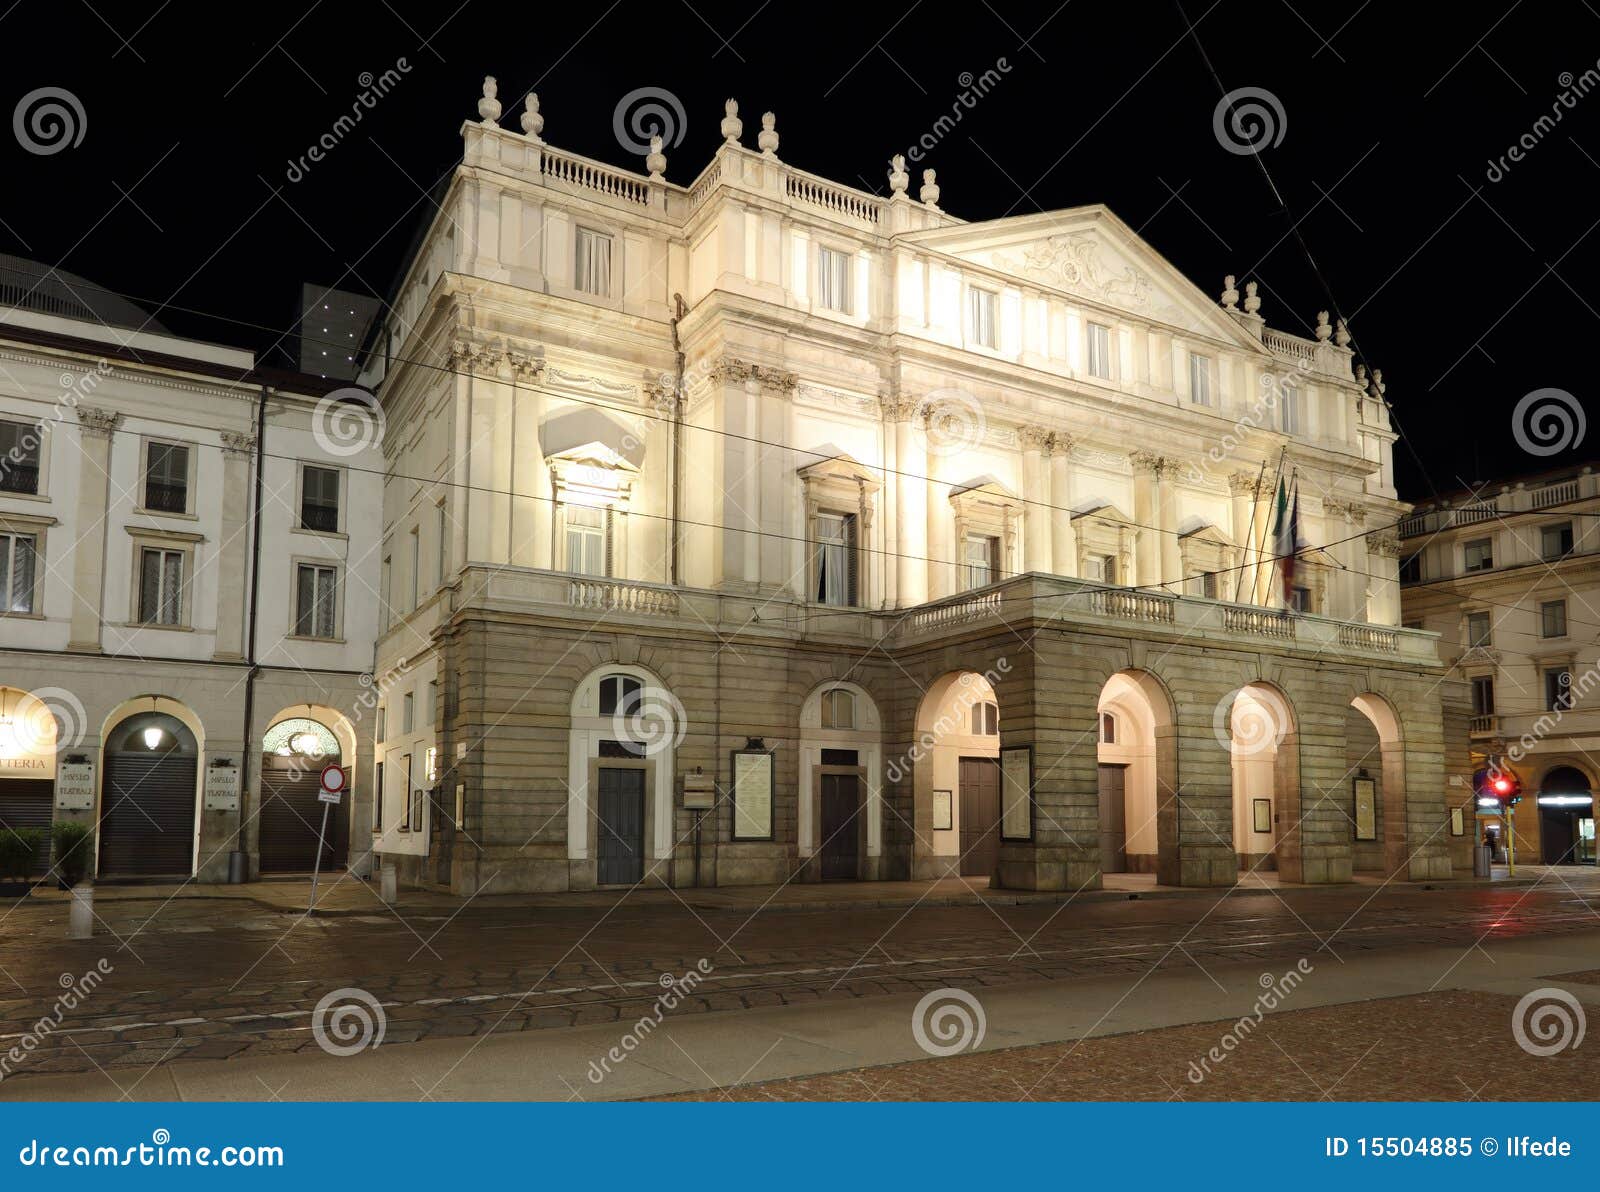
[910,670,1000,877]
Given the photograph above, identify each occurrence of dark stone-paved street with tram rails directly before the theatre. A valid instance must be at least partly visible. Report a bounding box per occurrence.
[0,874,1600,1075]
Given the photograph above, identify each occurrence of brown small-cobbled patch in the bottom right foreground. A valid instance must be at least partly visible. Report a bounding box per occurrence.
[659,978,1600,1100]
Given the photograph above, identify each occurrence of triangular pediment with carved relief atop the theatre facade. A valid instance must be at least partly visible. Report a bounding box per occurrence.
[904,205,1266,344]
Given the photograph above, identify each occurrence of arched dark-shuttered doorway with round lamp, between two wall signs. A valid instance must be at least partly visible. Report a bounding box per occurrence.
[99,701,200,877]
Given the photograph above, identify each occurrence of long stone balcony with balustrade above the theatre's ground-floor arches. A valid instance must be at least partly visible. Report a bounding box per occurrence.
[451,566,1440,667]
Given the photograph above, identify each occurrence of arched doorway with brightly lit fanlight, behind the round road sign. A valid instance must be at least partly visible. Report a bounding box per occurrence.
[258,717,350,874]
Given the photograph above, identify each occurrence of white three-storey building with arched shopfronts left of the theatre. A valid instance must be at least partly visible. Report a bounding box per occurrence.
[0,258,382,880]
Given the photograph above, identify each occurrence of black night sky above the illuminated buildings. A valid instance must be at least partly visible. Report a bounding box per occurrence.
[0,0,1600,499]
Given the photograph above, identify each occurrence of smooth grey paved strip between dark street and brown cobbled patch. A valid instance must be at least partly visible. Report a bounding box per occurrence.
[0,931,1600,1102]
